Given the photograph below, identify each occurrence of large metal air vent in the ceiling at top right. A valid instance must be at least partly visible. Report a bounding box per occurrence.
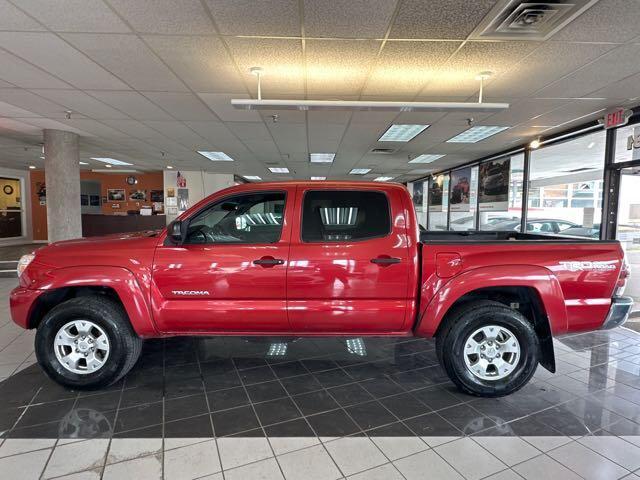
[471,0,597,40]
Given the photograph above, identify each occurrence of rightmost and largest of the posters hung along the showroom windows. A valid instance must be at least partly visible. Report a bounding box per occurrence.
[478,158,511,212]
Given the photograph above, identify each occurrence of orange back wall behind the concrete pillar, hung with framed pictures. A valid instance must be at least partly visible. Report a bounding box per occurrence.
[30,170,163,240]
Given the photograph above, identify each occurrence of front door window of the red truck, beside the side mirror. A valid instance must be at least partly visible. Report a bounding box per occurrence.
[185,192,285,244]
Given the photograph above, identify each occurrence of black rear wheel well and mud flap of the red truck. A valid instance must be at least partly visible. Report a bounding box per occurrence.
[435,287,556,373]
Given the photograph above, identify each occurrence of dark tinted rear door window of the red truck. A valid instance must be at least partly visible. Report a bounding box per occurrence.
[302,190,391,242]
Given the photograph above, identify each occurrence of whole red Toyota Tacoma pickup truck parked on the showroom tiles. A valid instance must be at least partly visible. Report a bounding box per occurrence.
[11,182,632,396]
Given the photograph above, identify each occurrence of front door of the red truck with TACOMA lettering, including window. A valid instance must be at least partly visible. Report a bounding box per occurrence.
[152,188,295,333]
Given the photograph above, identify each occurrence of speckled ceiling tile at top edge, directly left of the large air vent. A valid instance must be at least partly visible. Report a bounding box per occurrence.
[390,0,496,39]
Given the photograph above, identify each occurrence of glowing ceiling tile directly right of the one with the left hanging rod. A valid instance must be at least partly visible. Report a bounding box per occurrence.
[305,40,381,95]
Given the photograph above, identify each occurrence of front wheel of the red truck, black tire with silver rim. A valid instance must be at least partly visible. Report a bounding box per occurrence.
[35,296,142,390]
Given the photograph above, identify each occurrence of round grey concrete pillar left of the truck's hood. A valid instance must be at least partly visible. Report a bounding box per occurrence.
[44,130,82,242]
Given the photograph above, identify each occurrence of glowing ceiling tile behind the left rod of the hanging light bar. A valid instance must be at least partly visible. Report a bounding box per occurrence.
[227,38,304,98]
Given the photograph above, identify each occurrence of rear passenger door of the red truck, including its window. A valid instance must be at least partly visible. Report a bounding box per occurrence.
[287,187,414,334]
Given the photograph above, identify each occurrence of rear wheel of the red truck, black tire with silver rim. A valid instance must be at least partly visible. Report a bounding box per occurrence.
[436,300,540,397]
